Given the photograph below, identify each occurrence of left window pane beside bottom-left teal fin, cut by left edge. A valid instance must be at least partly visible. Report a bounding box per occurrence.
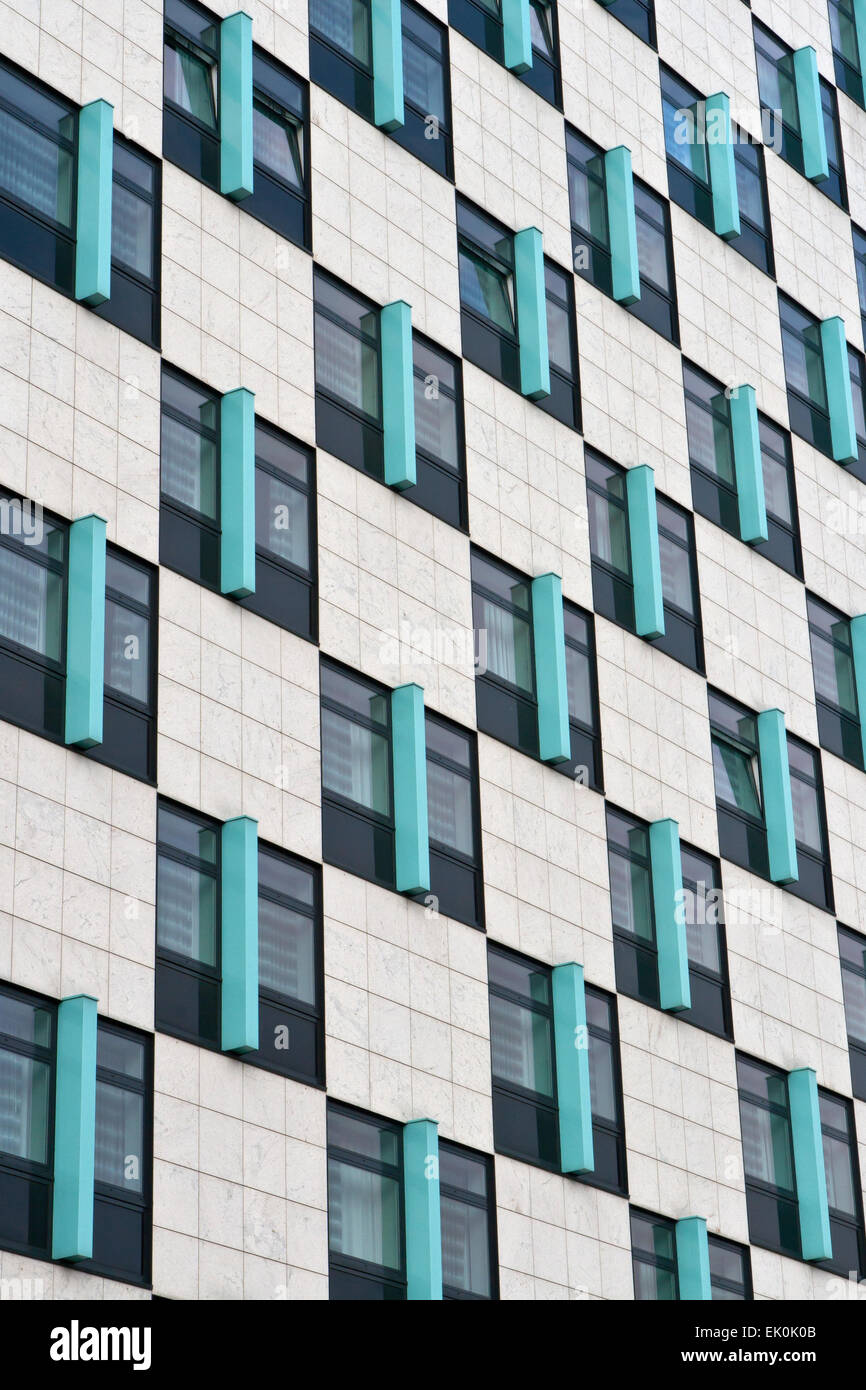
[0,984,57,1259]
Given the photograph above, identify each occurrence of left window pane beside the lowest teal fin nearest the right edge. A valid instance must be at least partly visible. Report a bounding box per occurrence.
[737,1056,801,1258]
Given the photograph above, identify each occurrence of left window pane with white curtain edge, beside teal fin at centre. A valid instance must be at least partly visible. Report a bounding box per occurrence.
[471,550,538,758]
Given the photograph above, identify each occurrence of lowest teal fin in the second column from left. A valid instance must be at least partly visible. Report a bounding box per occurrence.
[220,816,259,1052]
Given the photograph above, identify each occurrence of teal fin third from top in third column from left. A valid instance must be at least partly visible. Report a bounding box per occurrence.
[391,685,430,892]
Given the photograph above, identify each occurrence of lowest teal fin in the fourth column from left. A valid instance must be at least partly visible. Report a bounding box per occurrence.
[553,962,595,1173]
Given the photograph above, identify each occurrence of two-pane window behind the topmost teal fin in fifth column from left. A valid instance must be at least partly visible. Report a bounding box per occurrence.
[566,128,680,348]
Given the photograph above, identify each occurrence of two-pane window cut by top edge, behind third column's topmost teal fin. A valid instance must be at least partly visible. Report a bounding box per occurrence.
[310,0,453,179]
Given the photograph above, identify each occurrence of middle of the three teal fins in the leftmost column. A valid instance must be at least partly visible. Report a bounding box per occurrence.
[64,516,106,748]
